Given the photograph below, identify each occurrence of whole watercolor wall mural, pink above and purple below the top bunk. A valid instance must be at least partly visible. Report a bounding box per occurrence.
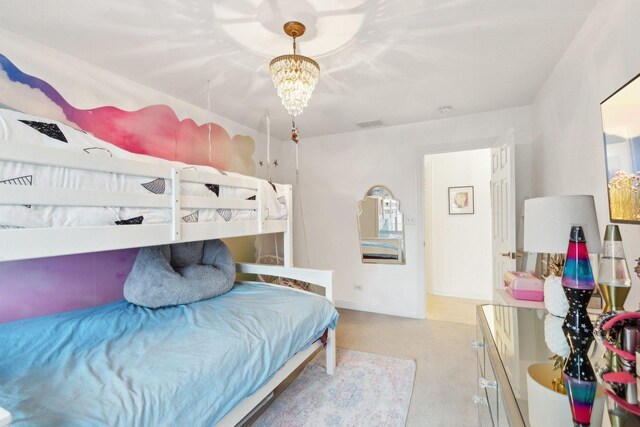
[0,54,255,323]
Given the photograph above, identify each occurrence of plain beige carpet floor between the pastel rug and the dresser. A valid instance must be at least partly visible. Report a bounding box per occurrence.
[336,309,478,427]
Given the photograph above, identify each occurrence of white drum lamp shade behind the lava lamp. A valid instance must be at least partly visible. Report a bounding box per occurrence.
[524,195,602,254]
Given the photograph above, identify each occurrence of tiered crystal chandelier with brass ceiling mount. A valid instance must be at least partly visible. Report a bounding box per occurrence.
[269,21,320,117]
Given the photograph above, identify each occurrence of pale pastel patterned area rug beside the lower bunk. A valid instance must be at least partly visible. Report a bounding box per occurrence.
[254,349,416,427]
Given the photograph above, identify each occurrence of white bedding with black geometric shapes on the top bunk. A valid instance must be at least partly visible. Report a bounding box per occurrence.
[0,109,287,228]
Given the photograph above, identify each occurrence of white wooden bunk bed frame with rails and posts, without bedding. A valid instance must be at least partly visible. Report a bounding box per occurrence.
[0,142,336,427]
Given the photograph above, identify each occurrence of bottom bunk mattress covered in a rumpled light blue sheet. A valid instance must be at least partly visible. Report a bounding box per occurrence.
[0,283,338,426]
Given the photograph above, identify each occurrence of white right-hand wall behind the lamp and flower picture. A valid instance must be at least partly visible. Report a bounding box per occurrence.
[532,0,640,304]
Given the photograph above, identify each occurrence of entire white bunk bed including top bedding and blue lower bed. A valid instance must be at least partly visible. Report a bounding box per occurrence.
[0,109,337,426]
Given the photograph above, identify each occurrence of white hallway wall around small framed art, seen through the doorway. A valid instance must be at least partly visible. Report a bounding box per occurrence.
[425,148,493,300]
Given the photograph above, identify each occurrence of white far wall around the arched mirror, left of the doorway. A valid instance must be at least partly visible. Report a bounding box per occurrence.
[280,107,531,317]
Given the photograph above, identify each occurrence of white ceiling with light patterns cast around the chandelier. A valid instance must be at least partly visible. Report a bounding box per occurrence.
[0,0,597,139]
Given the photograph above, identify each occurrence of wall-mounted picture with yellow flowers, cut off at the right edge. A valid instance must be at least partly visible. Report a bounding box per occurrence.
[600,74,640,224]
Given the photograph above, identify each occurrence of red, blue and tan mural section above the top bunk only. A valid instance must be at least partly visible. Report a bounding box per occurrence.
[0,54,255,175]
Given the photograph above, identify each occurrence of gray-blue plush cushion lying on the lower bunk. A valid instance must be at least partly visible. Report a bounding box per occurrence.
[124,240,236,308]
